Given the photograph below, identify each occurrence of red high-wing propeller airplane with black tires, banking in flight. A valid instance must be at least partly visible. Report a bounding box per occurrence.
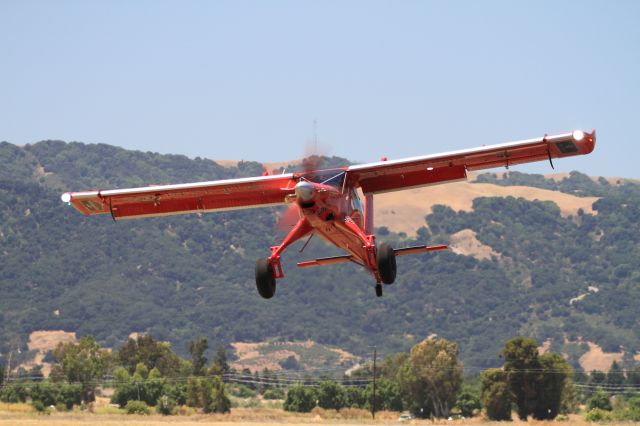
[62,130,596,299]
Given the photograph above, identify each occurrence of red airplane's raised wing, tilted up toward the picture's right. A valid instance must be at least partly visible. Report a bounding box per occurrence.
[347,130,596,194]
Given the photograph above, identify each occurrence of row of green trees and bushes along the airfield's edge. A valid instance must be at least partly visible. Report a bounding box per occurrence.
[0,335,640,420]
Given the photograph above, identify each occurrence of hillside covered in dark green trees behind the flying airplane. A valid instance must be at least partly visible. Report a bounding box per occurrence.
[0,141,640,368]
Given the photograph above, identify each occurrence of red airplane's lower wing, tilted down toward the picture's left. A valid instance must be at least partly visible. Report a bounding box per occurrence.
[62,173,295,219]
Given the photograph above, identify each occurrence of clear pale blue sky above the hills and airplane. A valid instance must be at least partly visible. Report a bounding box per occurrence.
[0,0,640,178]
